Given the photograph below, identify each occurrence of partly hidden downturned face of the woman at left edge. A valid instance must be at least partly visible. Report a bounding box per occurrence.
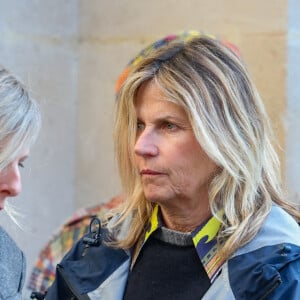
[0,150,29,210]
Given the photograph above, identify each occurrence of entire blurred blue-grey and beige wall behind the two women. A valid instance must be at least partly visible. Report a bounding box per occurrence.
[0,0,300,296]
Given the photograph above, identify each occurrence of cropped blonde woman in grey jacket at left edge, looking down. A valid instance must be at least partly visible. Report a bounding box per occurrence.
[0,66,40,300]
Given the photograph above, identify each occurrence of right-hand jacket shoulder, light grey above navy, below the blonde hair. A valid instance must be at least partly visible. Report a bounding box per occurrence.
[227,206,300,299]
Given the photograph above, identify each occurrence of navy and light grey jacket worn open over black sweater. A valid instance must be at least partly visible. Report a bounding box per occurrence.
[46,206,300,300]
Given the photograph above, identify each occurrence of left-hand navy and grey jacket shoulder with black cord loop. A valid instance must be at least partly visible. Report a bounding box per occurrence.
[46,218,130,299]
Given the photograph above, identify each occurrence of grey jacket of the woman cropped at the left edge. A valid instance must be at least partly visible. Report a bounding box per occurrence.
[0,226,25,300]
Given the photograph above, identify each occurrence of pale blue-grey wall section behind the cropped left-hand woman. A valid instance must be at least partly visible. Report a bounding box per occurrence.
[0,0,78,299]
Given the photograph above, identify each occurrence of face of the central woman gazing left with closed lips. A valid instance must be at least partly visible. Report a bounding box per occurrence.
[134,81,217,207]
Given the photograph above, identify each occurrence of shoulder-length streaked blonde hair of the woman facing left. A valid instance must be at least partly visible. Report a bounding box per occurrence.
[114,35,300,258]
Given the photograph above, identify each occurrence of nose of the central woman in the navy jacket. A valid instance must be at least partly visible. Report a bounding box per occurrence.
[134,129,159,156]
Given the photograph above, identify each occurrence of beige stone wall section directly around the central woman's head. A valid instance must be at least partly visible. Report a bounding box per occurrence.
[76,0,287,206]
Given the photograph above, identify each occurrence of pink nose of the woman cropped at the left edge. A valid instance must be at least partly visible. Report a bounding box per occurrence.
[0,165,22,197]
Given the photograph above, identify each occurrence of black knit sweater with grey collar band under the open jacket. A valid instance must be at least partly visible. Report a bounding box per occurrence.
[124,227,210,300]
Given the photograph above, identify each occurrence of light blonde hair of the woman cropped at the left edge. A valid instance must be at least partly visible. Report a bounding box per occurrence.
[0,65,41,221]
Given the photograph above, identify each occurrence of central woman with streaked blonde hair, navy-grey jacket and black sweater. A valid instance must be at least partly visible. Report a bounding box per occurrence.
[47,31,300,300]
